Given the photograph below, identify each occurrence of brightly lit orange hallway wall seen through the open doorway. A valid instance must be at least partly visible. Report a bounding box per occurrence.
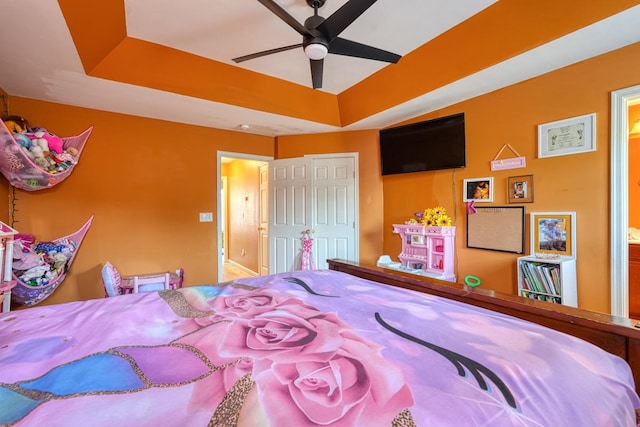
[226,160,260,272]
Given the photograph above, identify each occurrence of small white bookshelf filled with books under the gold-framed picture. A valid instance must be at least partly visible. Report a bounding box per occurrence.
[518,256,578,307]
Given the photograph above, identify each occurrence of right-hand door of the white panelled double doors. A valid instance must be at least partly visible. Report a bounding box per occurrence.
[312,157,357,269]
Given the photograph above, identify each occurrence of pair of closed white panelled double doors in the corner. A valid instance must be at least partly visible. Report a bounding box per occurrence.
[269,154,358,274]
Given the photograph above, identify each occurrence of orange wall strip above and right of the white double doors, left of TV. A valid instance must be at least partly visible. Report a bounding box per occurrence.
[276,131,383,263]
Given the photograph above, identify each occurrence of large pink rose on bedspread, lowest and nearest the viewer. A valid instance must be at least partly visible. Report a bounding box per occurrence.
[253,339,413,426]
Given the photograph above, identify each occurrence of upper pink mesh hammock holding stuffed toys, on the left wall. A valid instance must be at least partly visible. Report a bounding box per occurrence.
[0,120,93,191]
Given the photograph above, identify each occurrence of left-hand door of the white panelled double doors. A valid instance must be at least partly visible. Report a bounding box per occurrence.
[269,158,313,274]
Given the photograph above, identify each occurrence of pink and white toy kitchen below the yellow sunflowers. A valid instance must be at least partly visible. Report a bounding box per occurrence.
[393,224,456,282]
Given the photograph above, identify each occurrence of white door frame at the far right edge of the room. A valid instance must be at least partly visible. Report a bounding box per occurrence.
[609,85,640,317]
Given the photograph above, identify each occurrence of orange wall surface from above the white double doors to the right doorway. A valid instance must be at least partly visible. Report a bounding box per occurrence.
[276,44,640,312]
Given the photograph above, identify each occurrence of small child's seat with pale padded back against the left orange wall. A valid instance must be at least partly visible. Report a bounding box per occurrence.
[102,261,184,297]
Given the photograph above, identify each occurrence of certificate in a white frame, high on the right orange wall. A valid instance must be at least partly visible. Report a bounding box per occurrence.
[538,113,596,159]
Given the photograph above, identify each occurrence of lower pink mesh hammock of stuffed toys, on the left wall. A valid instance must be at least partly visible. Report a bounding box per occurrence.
[11,215,93,306]
